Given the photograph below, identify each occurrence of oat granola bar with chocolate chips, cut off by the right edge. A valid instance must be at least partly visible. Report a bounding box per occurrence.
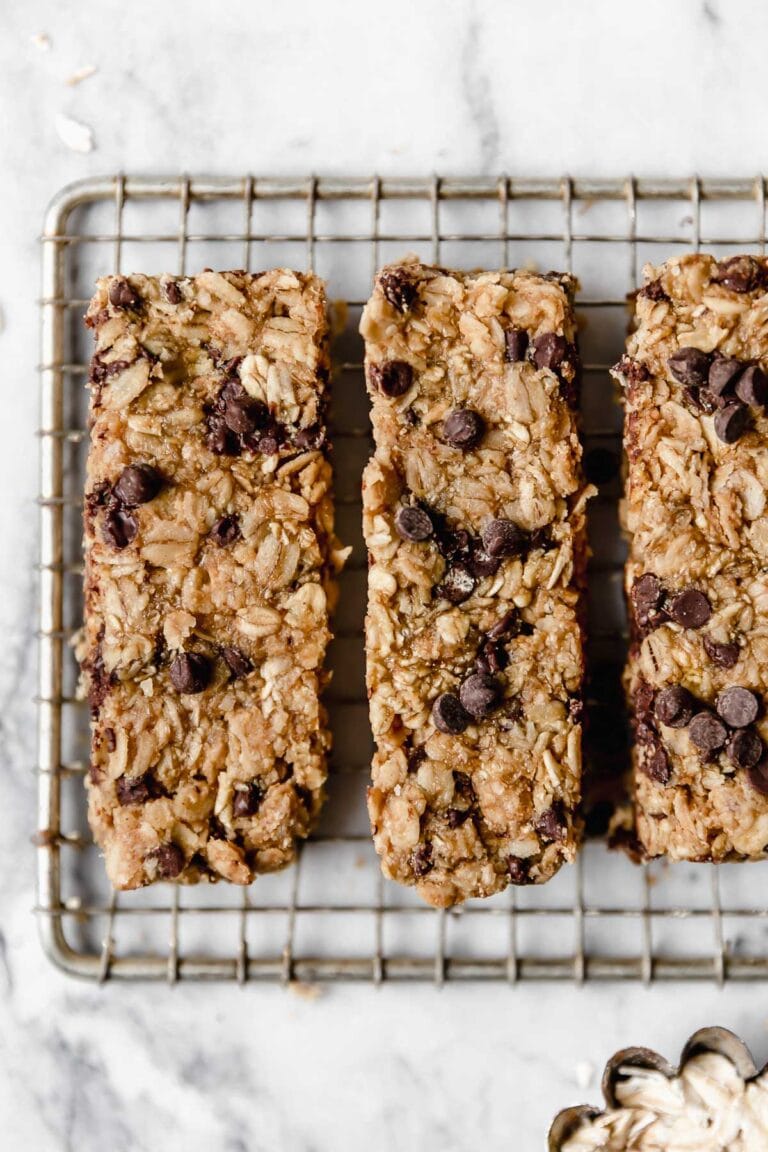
[616,255,768,861]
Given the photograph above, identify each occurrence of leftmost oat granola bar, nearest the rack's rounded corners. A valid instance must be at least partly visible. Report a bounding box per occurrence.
[82,270,342,888]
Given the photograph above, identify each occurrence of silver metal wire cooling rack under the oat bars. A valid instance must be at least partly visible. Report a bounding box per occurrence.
[37,176,768,984]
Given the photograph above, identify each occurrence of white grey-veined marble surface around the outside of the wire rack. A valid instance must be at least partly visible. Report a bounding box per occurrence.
[0,0,768,1152]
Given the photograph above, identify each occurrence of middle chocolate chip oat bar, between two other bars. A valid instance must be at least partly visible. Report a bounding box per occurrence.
[360,259,588,907]
